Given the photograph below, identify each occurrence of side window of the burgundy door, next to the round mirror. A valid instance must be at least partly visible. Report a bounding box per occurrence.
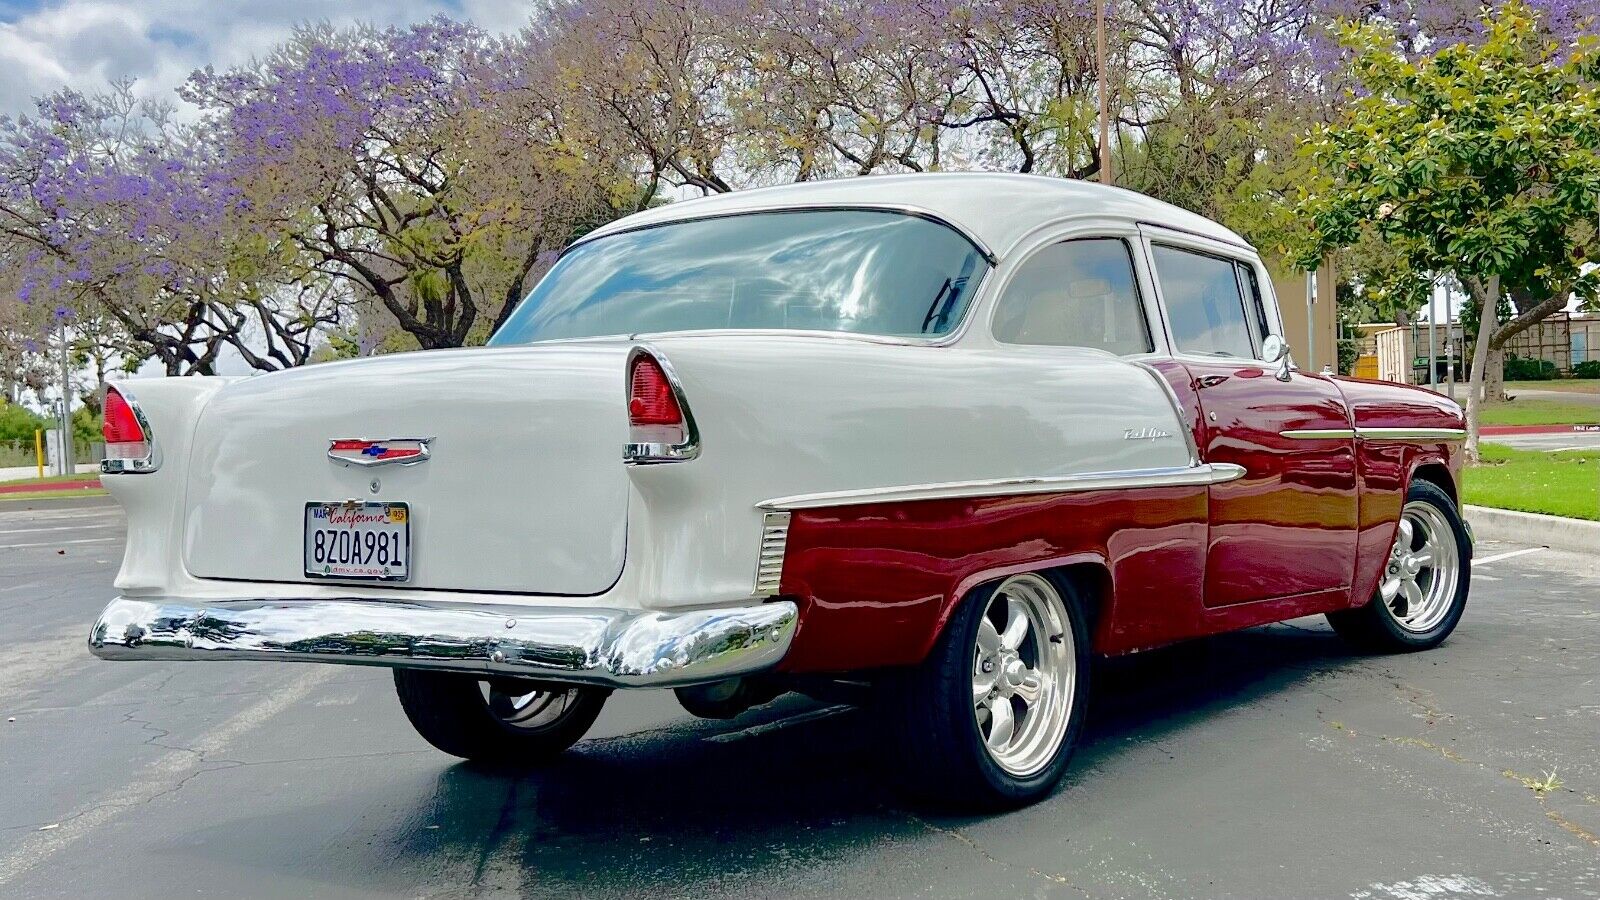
[1154,245,1256,359]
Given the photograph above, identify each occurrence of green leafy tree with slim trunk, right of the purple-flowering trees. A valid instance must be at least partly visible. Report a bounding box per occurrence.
[1299,0,1600,460]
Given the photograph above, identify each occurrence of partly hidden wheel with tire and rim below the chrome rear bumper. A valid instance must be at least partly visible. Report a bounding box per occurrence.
[395,669,610,765]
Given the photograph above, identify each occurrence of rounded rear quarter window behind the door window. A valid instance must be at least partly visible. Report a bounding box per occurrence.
[995,237,1154,356]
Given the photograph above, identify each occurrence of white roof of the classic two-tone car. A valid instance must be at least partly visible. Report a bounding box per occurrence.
[582,171,1248,256]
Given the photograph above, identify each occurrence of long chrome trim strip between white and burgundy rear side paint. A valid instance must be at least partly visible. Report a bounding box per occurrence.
[755,463,1245,511]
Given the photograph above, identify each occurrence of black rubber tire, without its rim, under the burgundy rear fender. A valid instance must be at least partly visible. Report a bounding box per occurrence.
[878,573,1090,810]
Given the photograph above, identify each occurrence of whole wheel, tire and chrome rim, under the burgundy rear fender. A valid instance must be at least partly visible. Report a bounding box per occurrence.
[886,573,1090,809]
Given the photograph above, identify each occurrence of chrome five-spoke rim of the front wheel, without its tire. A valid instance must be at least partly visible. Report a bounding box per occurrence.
[1378,500,1461,634]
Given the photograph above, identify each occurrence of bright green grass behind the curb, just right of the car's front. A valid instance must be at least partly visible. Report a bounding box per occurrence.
[1461,444,1600,519]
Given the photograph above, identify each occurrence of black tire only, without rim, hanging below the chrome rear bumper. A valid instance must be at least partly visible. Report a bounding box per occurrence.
[395,669,611,767]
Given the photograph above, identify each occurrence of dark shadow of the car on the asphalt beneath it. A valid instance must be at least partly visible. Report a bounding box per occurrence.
[368,620,1360,895]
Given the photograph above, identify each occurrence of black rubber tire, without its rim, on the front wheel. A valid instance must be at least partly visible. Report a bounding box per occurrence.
[1328,480,1472,653]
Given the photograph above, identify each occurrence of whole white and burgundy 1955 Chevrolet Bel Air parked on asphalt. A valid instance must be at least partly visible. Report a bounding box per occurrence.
[90,173,1472,806]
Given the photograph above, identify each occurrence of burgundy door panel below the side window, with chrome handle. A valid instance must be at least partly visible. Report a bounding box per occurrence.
[1182,359,1357,607]
